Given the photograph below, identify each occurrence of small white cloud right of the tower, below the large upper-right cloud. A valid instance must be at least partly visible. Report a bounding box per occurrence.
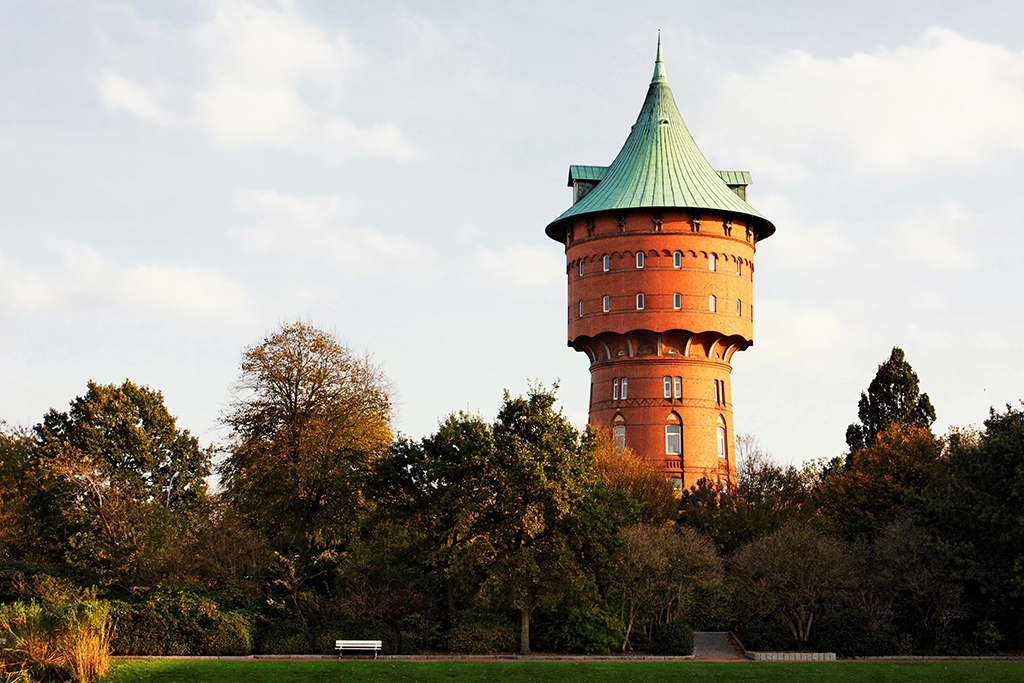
[887,201,978,270]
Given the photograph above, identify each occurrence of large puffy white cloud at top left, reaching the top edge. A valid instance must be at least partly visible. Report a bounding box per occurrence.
[95,0,420,159]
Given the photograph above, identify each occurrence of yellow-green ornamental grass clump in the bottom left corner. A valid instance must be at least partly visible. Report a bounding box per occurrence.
[0,599,113,683]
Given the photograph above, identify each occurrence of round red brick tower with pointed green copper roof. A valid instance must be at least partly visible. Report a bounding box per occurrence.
[545,39,775,488]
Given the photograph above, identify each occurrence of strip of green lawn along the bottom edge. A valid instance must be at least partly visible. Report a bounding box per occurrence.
[103,659,1024,683]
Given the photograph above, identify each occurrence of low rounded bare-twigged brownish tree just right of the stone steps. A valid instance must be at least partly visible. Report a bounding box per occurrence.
[729,524,856,647]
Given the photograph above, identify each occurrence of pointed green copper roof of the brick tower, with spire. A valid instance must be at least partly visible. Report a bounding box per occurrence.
[545,38,775,242]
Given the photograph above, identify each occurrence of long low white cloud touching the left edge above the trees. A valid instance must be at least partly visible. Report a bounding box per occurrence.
[0,243,254,323]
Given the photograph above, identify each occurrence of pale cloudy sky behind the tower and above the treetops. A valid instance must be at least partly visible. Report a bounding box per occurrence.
[0,0,1024,464]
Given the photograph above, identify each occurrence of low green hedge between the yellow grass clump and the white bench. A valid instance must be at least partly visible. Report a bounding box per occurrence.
[113,586,253,655]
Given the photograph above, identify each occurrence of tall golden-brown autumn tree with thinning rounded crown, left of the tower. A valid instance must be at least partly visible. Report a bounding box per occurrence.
[220,323,393,553]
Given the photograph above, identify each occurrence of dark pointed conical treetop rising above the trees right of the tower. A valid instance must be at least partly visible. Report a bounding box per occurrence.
[846,346,935,453]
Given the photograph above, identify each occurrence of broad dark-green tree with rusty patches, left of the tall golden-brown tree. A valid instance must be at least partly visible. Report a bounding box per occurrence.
[33,381,210,577]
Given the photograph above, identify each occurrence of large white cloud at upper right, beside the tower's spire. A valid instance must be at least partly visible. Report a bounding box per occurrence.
[709,28,1024,179]
